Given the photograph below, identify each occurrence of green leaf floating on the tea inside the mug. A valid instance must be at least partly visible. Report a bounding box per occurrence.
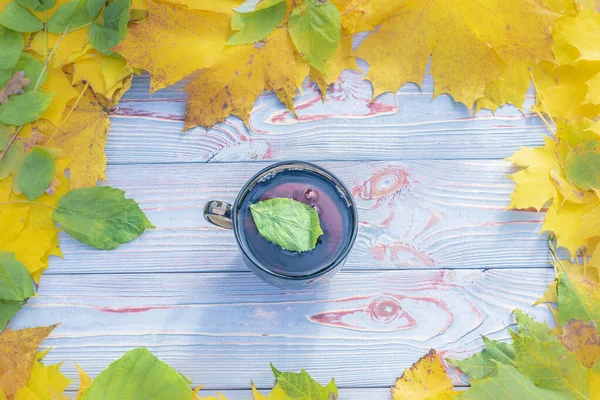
[250,198,323,252]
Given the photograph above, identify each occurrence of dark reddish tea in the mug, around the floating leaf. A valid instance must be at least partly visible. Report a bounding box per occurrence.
[239,170,353,276]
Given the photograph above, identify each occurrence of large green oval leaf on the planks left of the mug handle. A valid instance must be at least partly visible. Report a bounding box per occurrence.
[52,186,154,250]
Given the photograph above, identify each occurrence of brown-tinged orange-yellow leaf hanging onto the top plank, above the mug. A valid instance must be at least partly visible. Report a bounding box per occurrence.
[184,28,297,130]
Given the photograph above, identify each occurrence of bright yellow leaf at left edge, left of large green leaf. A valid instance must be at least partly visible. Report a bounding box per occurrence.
[0,159,69,283]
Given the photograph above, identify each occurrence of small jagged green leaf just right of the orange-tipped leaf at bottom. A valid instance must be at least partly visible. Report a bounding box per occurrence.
[447,336,515,379]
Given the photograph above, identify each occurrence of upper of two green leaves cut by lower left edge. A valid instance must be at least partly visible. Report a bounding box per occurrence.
[0,251,34,301]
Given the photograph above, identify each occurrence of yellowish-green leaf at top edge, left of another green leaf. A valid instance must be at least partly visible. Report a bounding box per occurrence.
[227,0,287,46]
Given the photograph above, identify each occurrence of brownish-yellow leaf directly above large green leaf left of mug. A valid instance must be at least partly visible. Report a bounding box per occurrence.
[35,88,110,189]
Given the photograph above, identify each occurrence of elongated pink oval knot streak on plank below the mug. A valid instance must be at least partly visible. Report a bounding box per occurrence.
[308,294,454,335]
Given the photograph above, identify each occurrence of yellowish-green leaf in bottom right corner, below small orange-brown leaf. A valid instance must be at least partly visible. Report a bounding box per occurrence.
[511,332,590,400]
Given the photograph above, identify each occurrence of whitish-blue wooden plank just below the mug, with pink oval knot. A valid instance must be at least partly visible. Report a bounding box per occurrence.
[12,268,553,389]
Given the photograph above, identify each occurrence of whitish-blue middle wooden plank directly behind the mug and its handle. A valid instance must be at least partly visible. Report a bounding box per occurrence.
[47,161,549,274]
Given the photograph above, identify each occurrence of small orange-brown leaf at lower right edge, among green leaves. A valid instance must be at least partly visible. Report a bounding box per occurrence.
[558,319,600,368]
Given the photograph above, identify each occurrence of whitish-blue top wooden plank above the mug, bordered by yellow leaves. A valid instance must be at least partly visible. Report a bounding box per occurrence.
[106,71,546,164]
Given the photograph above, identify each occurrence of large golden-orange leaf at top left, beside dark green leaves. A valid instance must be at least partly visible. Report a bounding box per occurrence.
[114,0,230,92]
